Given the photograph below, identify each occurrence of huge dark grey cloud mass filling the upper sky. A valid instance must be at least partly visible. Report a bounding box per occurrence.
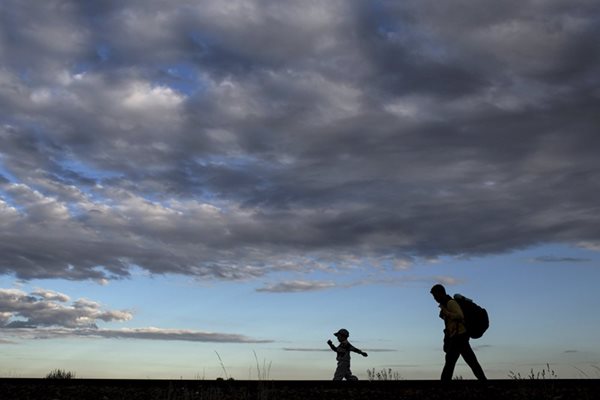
[0,0,600,282]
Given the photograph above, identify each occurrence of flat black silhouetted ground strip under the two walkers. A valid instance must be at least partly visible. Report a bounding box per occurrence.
[0,378,600,400]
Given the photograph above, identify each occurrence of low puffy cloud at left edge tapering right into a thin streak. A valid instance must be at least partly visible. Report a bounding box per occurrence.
[0,289,271,343]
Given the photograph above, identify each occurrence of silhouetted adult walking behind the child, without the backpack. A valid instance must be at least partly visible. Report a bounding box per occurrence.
[431,284,487,381]
